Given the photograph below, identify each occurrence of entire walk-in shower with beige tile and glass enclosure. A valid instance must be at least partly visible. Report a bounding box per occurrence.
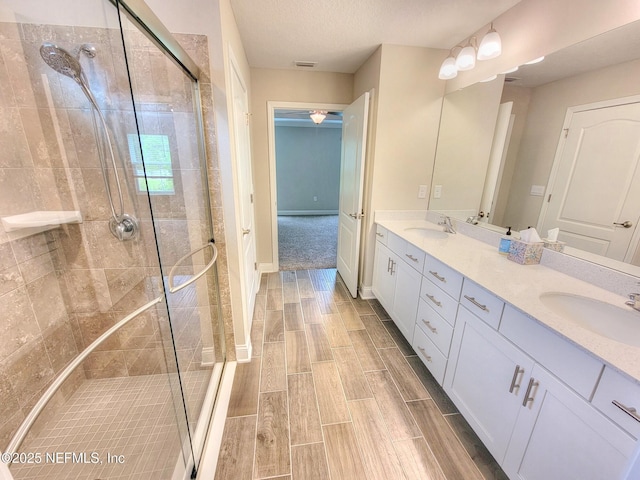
[0,0,230,480]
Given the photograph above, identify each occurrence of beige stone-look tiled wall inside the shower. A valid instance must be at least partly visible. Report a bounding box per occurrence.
[0,23,233,449]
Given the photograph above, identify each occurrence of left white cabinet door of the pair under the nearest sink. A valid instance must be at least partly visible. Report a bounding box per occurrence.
[444,305,534,463]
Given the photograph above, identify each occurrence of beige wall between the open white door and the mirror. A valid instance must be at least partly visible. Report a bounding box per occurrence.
[355,45,445,291]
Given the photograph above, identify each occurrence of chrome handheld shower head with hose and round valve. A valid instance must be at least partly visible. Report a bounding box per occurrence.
[40,42,140,241]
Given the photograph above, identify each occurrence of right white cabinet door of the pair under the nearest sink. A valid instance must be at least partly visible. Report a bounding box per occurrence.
[503,365,635,480]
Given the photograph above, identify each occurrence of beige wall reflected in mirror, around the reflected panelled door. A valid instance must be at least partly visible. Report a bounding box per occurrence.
[504,60,640,228]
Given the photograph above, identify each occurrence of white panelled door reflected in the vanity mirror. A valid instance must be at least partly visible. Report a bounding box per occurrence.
[542,103,640,261]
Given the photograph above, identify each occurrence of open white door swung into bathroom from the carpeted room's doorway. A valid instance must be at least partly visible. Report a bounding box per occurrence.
[337,93,369,298]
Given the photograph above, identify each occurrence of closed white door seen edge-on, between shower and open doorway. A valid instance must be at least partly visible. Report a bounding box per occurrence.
[230,61,258,325]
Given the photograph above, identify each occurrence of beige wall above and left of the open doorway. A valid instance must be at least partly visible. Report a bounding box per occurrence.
[251,68,353,264]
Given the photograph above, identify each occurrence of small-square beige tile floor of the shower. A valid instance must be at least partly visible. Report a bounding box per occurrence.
[11,369,211,480]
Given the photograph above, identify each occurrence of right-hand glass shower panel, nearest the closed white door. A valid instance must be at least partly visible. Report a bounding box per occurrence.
[123,5,225,472]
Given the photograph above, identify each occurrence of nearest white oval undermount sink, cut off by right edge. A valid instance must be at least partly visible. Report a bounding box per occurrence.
[540,292,640,347]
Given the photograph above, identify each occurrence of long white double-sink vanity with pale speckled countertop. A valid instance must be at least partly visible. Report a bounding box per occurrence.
[372,215,640,480]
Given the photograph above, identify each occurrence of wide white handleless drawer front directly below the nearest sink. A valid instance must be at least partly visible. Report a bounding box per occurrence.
[498,305,604,400]
